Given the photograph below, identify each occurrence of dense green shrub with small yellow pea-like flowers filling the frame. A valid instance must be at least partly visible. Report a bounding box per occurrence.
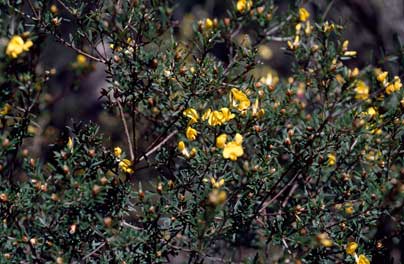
[0,0,404,264]
